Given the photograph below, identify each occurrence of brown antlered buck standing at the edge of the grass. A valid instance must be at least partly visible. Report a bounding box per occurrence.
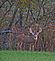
[17,25,42,50]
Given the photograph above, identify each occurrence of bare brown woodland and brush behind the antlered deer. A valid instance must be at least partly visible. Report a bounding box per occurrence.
[0,0,55,51]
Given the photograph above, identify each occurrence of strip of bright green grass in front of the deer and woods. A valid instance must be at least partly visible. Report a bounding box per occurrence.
[0,51,55,61]
